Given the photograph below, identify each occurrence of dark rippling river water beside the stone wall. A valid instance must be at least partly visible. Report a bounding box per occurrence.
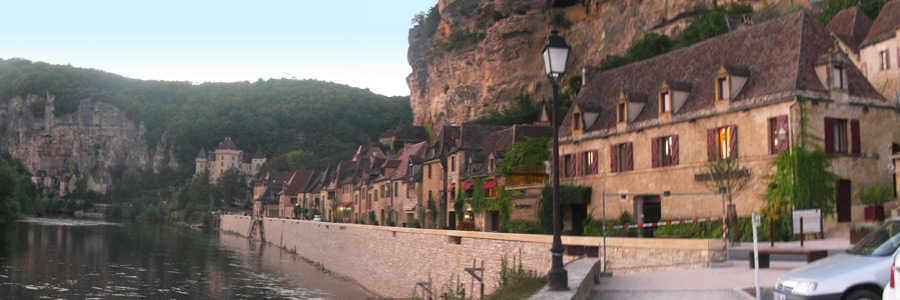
[0,218,371,299]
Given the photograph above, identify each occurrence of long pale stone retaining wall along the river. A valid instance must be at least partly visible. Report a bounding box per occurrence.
[221,215,722,297]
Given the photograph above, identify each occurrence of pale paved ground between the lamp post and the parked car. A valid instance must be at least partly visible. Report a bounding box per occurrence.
[594,261,806,300]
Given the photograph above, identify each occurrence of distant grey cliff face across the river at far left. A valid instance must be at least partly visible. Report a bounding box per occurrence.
[0,95,177,192]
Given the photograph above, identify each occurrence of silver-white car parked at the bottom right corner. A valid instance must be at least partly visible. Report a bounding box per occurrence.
[773,218,900,300]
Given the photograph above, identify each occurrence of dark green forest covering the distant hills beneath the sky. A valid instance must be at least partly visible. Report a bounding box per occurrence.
[0,59,412,169]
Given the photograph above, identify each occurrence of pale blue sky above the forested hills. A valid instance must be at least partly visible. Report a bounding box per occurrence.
[0,0,437,96]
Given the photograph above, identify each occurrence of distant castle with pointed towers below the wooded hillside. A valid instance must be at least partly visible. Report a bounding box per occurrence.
[194,137,266,182]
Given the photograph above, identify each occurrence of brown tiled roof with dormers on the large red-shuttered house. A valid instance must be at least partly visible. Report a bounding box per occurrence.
[560,11,884,136]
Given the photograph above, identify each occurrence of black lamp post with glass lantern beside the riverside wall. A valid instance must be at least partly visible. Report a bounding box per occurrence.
[543,30,569,291]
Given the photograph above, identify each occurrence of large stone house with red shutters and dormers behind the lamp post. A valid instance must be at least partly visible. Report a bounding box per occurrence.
[559,12,898,236]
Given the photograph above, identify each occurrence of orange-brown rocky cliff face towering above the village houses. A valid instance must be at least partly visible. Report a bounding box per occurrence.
[407,0,803,126]
